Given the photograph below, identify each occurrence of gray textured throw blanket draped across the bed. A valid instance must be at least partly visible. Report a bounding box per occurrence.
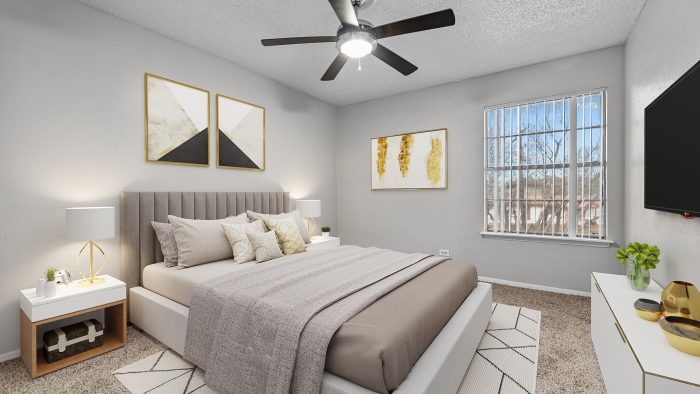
[185,246,444,394]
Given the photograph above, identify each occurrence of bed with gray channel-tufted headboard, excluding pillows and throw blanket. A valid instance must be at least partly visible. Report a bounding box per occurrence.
[120,192,491,394]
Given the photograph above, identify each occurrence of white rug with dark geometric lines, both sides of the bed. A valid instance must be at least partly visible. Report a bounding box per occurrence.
[113,304,540,394]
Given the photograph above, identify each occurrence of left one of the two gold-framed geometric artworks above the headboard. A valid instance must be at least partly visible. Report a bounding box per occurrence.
[144,73,209,166]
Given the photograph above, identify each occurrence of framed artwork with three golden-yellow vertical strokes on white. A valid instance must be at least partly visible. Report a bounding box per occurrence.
[371,129,447,190]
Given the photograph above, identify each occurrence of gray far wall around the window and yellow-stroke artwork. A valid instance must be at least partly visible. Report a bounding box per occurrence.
[338,47,624,291]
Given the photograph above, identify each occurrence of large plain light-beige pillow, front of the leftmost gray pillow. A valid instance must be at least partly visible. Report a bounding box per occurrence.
[168,214,248,267]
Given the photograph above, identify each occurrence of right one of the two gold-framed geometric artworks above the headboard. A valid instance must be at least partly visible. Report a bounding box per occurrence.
[216,94,265,171]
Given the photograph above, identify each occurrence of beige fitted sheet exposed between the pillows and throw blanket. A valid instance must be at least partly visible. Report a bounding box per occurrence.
[143,259,255,308]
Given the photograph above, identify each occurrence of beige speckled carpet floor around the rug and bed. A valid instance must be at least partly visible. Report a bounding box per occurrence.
[0,285,605,393]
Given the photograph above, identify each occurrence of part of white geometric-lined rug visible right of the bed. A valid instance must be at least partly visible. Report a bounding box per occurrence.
[458,304,541,394]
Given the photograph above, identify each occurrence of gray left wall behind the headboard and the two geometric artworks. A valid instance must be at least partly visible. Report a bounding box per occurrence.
[0,0,336,355]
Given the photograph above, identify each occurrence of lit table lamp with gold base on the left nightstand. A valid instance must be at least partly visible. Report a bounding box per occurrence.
[66,207,114,286]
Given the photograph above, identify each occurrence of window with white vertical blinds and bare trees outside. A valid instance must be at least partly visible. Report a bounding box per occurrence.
[484,90,606,240]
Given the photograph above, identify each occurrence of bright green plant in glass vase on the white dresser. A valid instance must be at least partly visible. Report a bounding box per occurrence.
[615,242,661,291]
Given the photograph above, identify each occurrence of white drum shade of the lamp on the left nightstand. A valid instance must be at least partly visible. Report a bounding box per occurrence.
[66,207,114,241]
